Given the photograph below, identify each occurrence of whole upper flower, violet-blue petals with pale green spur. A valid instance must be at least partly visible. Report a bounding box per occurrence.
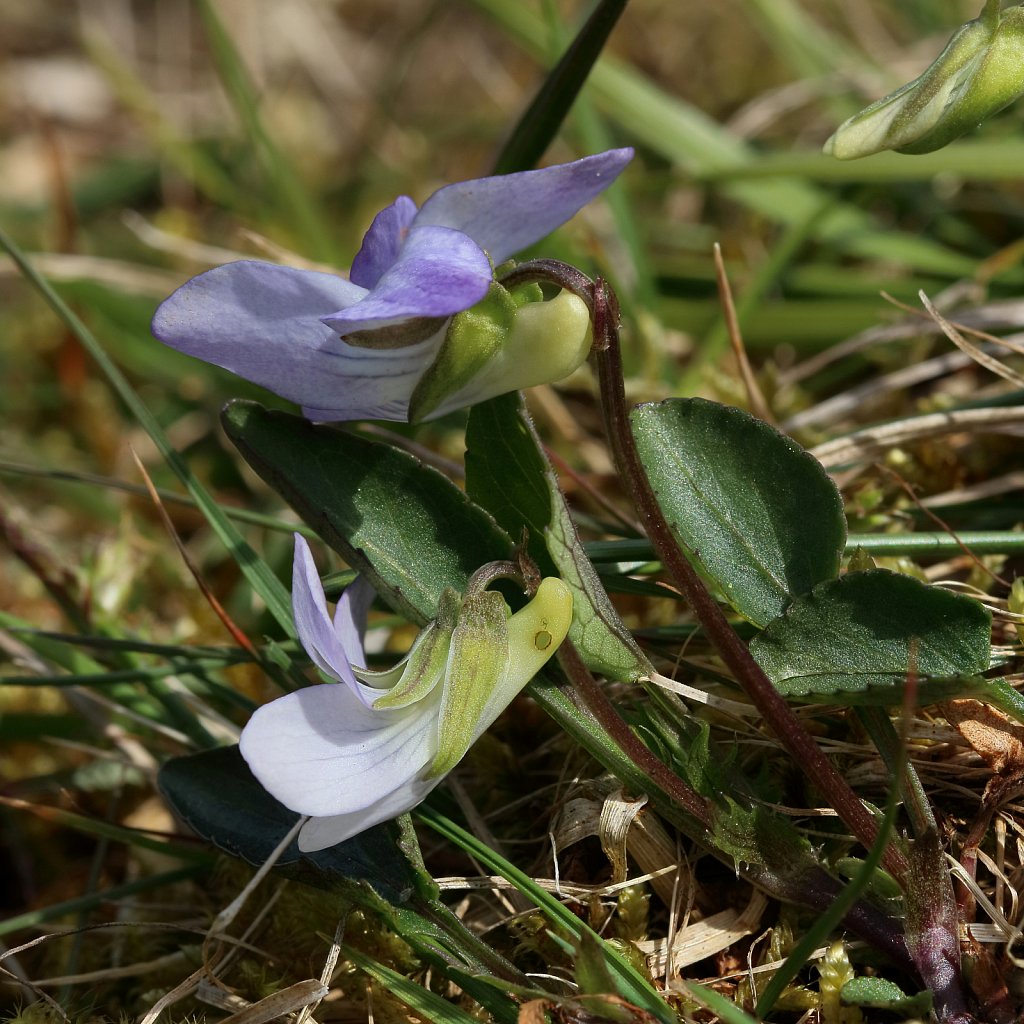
[153,148,633,421]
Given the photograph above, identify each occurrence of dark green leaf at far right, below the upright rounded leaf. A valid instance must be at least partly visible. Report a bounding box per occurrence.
[751,569,991,703]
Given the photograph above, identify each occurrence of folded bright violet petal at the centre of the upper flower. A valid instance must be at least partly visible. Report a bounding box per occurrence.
[323,225,493,335]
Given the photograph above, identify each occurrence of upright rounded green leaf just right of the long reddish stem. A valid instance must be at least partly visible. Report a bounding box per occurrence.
[631,398,846,626]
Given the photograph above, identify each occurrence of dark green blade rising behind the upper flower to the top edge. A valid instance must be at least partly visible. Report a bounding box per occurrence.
[492,0,627,174]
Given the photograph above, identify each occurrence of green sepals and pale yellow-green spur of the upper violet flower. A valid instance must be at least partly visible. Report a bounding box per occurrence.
[409,283,593,423]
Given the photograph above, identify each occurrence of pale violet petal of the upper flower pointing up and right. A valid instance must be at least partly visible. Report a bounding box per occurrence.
[411,148,633,265]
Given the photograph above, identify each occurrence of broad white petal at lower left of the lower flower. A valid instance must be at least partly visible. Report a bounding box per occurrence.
[239,683,440,817]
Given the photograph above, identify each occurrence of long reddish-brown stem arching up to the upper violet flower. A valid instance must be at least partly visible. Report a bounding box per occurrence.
[592,280,909,884]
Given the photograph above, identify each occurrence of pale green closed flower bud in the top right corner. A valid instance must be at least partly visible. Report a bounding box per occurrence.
[824,0,1024,160]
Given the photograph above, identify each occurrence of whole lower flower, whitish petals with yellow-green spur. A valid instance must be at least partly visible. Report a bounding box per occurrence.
[240,535,572,852]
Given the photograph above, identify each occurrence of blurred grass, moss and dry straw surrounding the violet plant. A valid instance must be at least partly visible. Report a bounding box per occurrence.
[0,0,1024,1020]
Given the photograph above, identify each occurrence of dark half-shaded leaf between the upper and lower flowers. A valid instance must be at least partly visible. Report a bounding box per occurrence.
[222,401,511,623]
